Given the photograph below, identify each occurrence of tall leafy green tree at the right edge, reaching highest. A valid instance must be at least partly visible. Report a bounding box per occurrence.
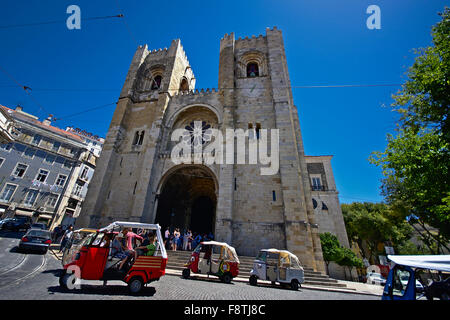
[369,8,450,253]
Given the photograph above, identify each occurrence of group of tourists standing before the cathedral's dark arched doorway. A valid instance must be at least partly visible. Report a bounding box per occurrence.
[164,227,214,251]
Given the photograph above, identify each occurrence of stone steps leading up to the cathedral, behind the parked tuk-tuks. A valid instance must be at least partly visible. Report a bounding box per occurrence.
[166,250,347,289]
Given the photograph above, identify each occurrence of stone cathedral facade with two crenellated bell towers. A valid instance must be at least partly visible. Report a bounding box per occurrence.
[77,27,352,272]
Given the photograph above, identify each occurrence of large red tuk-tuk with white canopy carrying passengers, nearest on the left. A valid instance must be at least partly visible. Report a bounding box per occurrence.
[59,221,167,294]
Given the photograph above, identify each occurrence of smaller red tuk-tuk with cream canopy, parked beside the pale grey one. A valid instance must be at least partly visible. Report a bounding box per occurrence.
[183,241,239,283]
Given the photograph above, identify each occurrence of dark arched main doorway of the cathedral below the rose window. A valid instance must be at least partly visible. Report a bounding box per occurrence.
[155,165,217,234]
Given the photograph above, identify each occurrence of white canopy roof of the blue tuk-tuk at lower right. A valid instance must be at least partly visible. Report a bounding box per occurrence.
[388,255,450,272]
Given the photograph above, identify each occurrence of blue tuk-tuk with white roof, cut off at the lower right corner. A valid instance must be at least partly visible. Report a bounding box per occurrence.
[382,255,450,300]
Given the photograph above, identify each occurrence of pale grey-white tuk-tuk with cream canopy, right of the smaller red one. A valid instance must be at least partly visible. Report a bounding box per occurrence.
[249,249,305,290]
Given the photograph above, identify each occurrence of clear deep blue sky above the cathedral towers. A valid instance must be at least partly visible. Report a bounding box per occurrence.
[0,0,448,203]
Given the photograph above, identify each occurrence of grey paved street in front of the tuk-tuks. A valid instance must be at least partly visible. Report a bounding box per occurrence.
[0,231,379,300]
